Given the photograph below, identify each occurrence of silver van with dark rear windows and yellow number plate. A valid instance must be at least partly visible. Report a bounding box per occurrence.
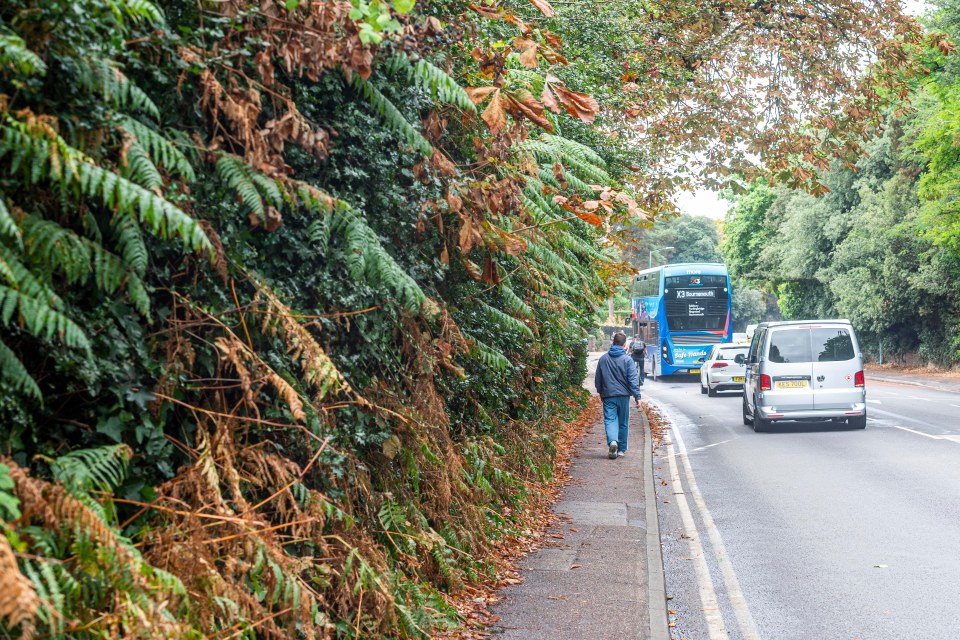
[743,320,867,431]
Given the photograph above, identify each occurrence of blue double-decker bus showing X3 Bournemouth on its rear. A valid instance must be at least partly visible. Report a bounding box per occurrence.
[632,262,732,375]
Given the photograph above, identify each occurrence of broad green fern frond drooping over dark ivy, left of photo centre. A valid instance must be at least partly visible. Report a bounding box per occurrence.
[333,201,426,313]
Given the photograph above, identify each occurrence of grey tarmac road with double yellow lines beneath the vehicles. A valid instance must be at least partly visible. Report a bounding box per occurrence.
[643,372,960,640]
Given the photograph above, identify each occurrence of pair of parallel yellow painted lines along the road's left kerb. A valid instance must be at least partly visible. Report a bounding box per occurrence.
[648,400,760,640]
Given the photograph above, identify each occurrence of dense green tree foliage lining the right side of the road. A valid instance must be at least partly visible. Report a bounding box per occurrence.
[723,37,960,365]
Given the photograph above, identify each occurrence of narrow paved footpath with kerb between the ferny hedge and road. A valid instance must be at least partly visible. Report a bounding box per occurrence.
[491,400,669,640]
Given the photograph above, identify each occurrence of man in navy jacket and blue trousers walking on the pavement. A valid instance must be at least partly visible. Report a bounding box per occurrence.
[593,333,640,460]
